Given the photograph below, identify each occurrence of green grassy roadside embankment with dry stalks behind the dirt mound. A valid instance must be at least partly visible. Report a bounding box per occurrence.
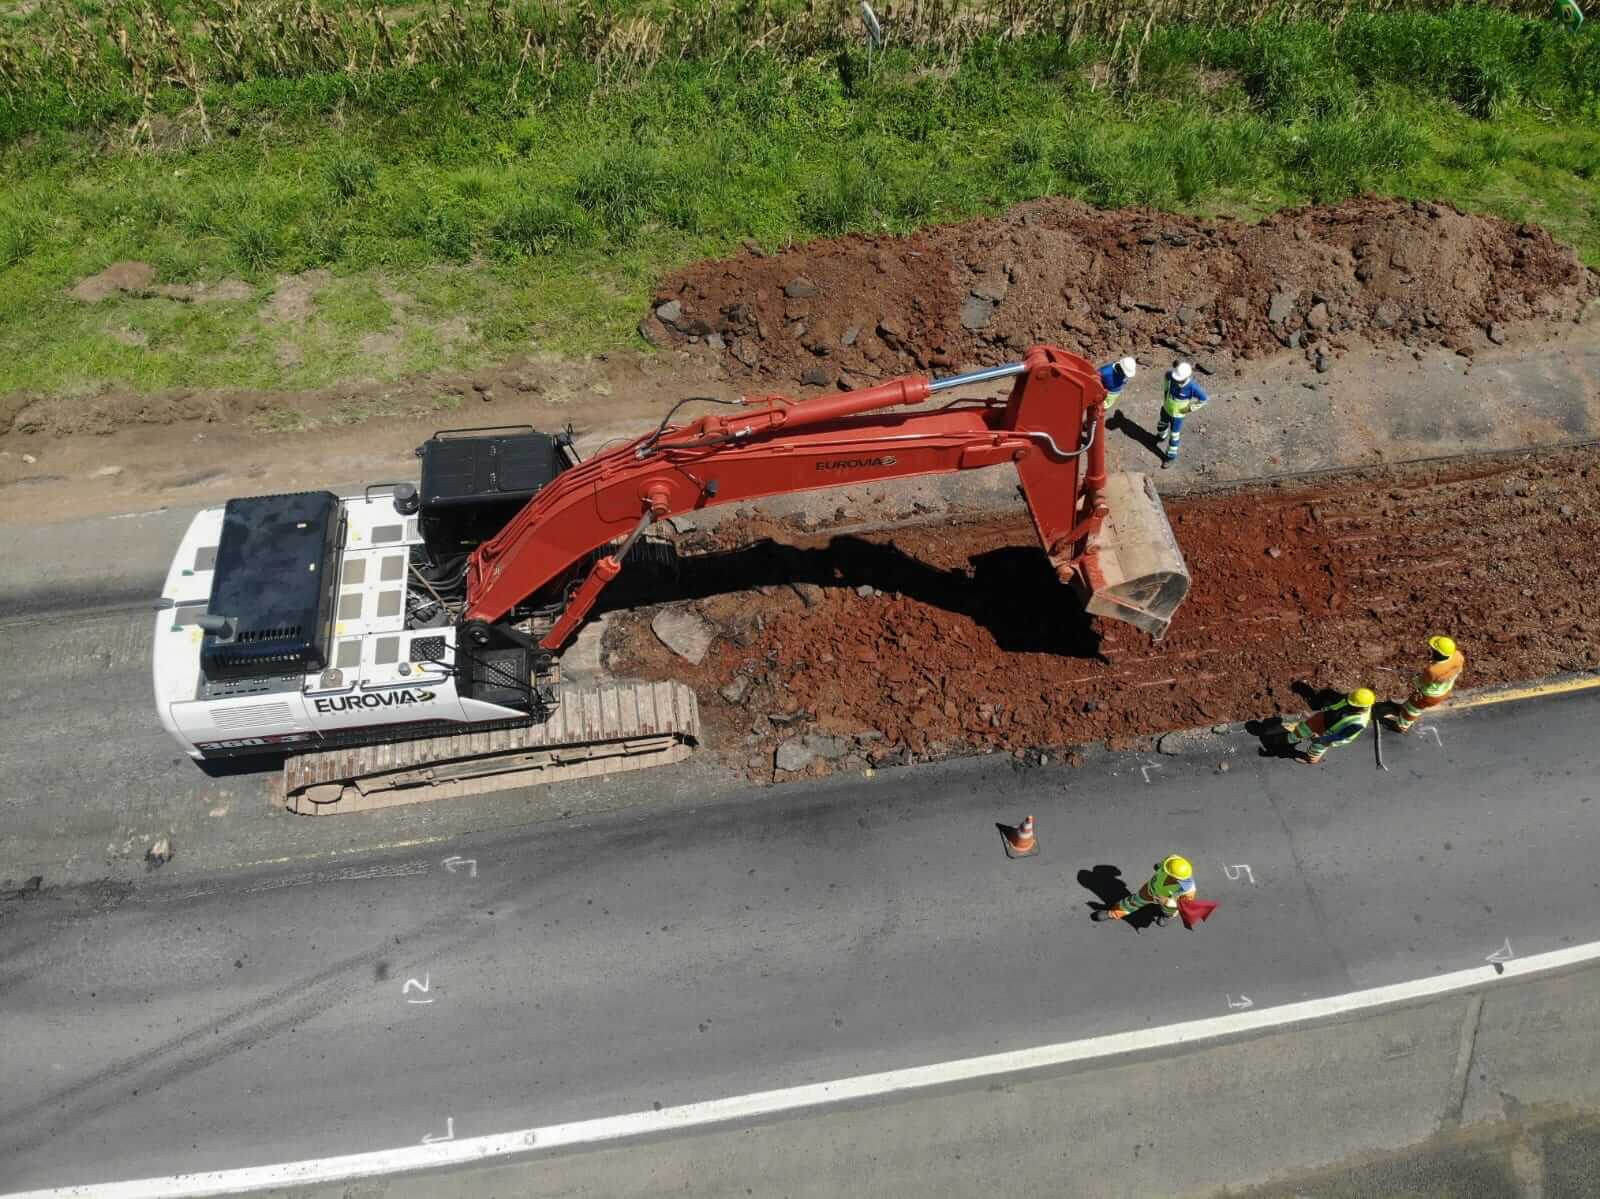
[0,0,1600,427]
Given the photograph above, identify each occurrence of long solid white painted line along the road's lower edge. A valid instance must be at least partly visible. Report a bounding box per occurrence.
[18,941,1600,1199]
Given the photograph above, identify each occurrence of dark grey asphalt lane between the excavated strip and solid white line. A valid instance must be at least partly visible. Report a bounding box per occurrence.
[0,681,1600,1189]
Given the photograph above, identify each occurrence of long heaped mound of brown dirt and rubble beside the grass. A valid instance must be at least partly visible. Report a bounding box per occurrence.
[640,198,1600,387]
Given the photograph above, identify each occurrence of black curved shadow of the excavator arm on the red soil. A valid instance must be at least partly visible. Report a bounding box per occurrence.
[597,535,1101,658]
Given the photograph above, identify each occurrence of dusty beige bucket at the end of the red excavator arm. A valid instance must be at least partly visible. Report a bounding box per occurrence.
[1078,474,1189,640]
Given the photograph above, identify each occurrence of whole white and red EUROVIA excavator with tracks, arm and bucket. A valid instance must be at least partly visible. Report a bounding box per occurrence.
[152,346,1189,815]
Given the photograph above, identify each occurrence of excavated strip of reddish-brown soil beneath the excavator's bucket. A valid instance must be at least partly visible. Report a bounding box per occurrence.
[610,448,1600,776]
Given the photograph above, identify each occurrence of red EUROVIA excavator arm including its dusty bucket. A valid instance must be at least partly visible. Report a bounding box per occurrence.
[462,346,1189,650]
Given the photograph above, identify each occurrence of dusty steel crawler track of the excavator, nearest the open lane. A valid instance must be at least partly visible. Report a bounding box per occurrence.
[282,682,699,816]
